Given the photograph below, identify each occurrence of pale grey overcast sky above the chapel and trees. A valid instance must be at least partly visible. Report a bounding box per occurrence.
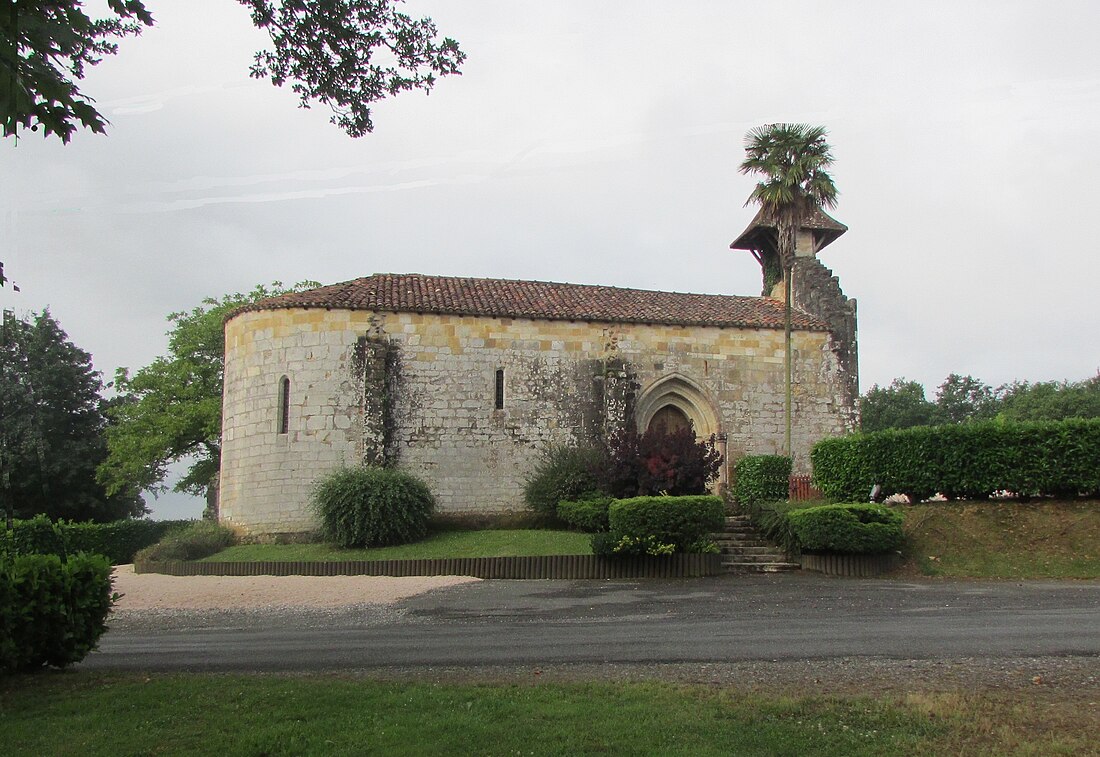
[0,0,1100,516]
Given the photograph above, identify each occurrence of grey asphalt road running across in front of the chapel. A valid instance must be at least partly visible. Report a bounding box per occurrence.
[80,573,1100,671]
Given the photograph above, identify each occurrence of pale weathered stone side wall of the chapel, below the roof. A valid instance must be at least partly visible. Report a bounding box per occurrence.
[220,309,853,534]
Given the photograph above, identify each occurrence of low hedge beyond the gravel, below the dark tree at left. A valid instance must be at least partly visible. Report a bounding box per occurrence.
[4,515,193,566]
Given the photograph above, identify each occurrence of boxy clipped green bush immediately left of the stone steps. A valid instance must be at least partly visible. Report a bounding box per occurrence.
[607,495,726,553]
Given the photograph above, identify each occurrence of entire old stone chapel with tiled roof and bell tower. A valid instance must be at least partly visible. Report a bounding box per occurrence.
[219,211,859,536]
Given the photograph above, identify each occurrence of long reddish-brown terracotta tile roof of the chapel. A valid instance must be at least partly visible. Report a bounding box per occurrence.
[236,274,828,331]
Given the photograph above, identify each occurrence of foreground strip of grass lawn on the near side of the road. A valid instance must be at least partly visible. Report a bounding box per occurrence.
[0,672,1098,757]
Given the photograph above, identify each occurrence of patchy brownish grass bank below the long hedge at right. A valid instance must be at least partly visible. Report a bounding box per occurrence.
[902,501,1100,579]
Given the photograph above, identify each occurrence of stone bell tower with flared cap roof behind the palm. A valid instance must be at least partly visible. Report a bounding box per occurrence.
[729,208,859,407]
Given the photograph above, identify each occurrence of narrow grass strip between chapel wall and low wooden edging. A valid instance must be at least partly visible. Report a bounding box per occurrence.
[206,529,592,562]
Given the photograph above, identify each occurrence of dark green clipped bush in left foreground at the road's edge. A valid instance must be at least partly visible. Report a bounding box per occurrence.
[0,555,113,672]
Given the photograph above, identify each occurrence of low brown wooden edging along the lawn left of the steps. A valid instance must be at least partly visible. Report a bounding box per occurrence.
[134,555,723,579]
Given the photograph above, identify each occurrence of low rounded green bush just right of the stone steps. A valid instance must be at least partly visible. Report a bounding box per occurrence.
[787,504,904,555]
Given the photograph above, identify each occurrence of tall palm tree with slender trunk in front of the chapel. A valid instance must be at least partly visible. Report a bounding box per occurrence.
[740,123,837,457]
